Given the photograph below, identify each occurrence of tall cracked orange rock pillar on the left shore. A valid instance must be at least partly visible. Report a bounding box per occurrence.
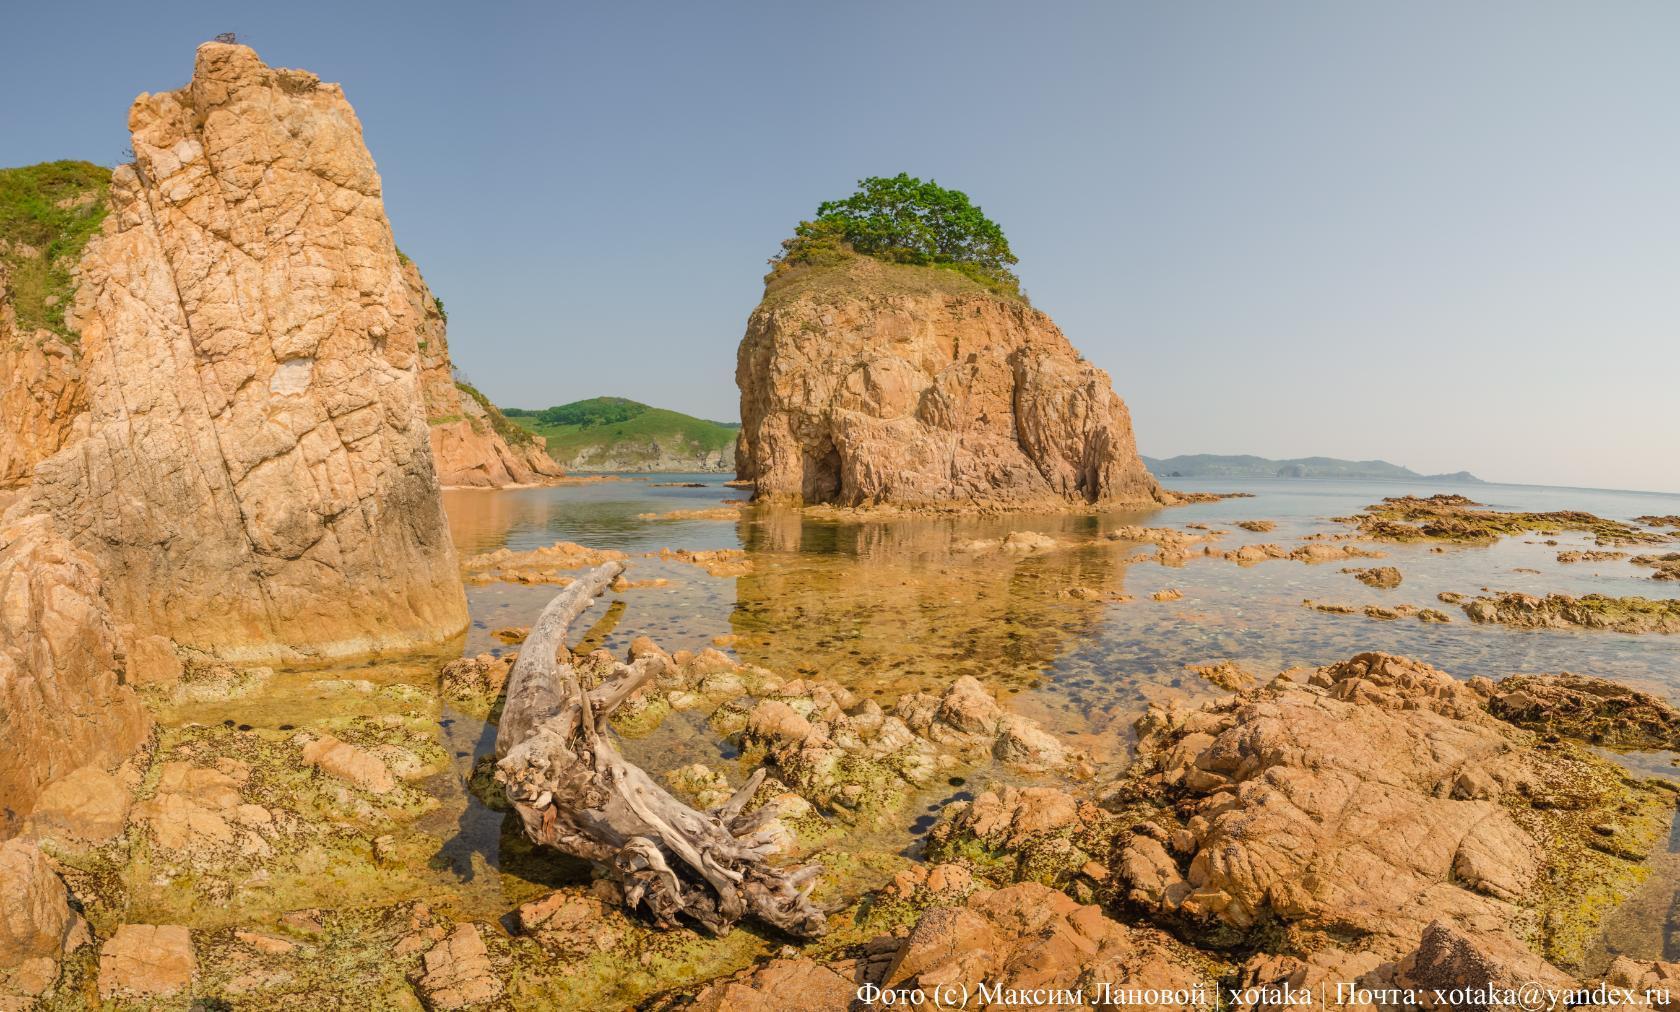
[25,44,467,661]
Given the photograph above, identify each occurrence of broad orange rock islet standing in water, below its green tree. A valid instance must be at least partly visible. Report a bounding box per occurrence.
[736,257,1161,506]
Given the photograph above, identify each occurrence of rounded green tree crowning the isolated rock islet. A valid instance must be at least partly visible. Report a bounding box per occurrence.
[769,171,1025,298]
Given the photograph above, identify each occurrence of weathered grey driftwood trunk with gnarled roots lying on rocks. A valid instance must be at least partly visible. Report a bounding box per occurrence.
[496,561,827,938]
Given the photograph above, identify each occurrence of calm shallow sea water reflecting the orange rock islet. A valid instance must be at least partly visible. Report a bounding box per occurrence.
[447,476,1680,702]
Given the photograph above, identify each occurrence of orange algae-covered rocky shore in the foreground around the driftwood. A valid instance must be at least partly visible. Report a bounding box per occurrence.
[13,553,1680,1009]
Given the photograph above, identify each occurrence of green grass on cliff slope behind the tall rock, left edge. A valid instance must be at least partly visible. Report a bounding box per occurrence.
[0,161,111,341]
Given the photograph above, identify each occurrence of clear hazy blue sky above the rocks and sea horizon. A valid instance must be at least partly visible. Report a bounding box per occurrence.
[0,0,1680,491]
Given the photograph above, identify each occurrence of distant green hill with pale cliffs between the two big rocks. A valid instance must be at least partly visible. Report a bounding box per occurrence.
[504,397,741,471]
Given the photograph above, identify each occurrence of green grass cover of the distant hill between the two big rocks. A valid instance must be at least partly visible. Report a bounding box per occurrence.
[504,397,741,461]
